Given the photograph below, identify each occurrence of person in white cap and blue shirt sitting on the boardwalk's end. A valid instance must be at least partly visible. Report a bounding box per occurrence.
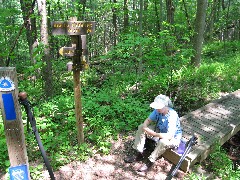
[124,94,182,172]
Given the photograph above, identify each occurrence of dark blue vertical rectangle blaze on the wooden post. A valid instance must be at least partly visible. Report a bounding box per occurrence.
[2,93,16,121]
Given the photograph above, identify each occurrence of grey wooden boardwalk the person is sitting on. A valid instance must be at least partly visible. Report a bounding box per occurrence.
[163,90,240,171]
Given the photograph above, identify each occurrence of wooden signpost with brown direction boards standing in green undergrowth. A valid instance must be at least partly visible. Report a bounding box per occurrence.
[51,17,95,144]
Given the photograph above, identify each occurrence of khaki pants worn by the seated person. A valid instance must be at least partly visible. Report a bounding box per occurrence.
[133,124,180,162]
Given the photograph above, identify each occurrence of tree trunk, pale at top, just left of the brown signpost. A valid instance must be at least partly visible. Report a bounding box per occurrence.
[37,0,53,97]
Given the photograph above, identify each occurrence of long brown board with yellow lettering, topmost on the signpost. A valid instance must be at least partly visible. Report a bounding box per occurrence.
[51,21,96,35]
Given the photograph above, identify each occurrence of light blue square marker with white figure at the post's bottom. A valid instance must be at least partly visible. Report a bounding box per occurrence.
[9,164,29,180]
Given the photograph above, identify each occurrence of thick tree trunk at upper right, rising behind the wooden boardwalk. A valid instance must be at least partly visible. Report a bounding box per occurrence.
[191,0,207,67]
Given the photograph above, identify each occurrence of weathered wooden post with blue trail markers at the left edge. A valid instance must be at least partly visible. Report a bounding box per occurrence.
[0,67,30,180]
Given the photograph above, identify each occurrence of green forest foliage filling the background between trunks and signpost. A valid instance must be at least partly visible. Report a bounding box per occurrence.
[0,0,240,179]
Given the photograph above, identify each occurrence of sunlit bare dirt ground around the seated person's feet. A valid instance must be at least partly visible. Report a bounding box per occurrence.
[52,135,185,180]
